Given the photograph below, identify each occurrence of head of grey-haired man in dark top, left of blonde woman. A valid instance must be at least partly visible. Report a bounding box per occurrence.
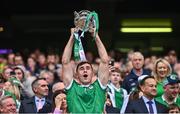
[132,52,144,70]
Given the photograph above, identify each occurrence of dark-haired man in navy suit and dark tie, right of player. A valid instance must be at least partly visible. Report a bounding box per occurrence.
[125,76,168,114]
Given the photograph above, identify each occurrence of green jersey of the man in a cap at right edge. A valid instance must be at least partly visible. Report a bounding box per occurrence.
[155,95,180,107]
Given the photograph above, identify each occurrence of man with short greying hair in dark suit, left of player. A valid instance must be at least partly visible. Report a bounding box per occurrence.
[19,78,52,113]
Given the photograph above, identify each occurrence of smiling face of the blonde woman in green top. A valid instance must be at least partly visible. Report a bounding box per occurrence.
[157,62,168,78]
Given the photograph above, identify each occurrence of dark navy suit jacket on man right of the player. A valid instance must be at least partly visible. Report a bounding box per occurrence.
[125,98,168,113]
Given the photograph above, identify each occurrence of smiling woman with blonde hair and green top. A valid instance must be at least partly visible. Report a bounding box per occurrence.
[152,58,172,97]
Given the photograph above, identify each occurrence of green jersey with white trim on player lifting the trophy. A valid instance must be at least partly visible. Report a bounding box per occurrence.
[66,80,106,113]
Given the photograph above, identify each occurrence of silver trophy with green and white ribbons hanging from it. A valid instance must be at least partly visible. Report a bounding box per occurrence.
[74,10,99,61]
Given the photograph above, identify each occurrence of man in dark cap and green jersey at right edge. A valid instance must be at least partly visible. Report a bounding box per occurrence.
[156,74,180,107]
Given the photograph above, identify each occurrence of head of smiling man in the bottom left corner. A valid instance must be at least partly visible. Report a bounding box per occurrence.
[0,97,16,114]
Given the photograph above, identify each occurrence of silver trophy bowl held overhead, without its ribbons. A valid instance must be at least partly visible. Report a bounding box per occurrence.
[74,10,96,32]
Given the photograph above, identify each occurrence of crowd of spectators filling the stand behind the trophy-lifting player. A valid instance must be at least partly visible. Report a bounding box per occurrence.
[0,42,180,114]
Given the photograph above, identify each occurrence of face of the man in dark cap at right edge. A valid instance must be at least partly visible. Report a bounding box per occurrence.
[164,83,180,99]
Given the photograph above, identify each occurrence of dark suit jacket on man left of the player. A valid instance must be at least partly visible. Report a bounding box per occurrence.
[19,97,52,113]
